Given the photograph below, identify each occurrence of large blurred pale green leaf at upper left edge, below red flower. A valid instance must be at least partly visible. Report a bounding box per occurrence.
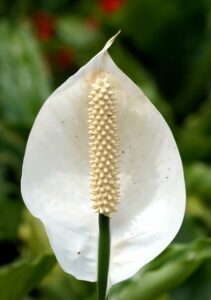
[0,21,50,125]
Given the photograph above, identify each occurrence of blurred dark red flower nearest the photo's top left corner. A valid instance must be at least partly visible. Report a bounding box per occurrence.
[33,12,54,41]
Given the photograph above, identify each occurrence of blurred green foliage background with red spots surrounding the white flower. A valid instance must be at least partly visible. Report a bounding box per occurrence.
[0,0,211,300]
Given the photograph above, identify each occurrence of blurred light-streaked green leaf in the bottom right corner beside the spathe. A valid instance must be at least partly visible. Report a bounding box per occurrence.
[109,239,211,300]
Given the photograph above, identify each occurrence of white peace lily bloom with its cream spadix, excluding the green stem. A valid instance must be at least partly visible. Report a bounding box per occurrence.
[21,32,185,296]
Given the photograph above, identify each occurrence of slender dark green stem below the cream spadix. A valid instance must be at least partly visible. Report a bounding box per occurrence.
[97,214,110,300]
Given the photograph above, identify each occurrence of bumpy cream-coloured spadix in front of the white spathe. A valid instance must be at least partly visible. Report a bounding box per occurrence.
[88,77,119,216]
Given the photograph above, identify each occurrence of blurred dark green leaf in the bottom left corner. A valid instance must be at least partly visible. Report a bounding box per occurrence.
[0,255,56,300]
